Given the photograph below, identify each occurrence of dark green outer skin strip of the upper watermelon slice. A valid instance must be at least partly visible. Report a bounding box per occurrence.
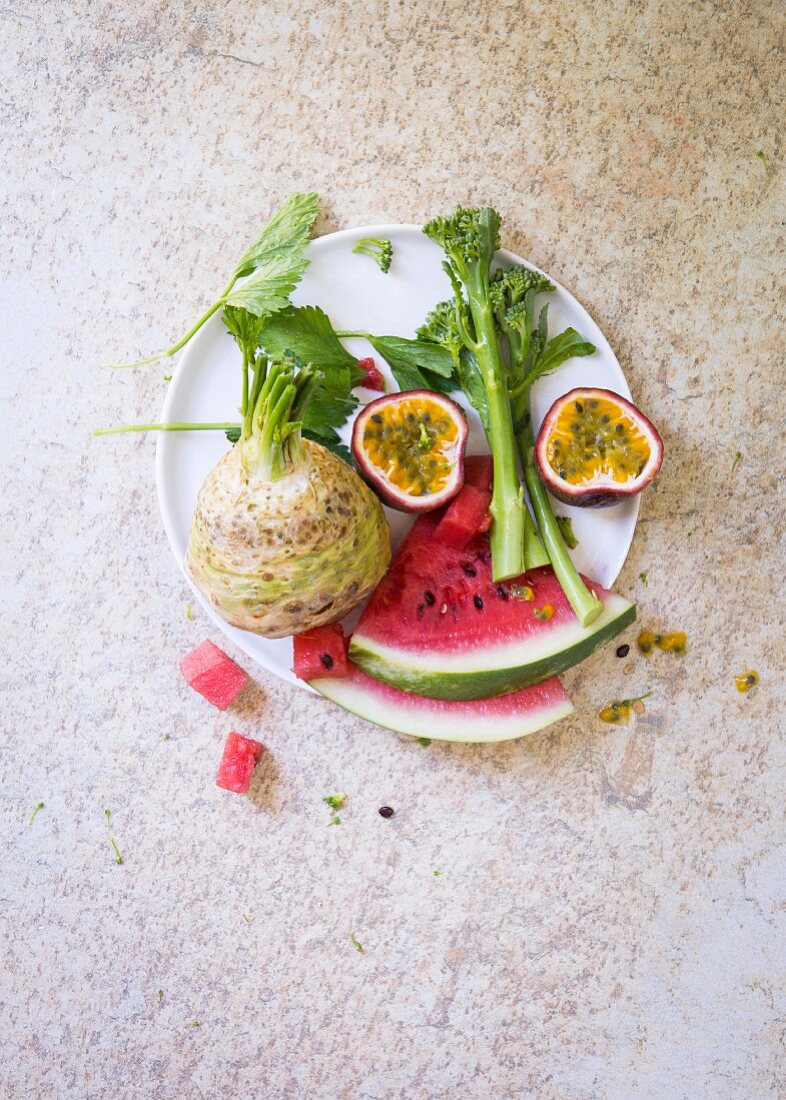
[350,604,635,701]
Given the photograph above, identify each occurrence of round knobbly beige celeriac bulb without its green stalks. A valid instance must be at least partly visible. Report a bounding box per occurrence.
[186,440,390,638]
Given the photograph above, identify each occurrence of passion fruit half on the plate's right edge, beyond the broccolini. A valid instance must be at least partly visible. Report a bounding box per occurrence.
[534,388,663,508]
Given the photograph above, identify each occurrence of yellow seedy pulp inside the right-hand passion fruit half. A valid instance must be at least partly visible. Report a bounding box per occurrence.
[546,398,651,485]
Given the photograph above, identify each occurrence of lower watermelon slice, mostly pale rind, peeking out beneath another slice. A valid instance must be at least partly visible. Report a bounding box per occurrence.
[310,664,573,741]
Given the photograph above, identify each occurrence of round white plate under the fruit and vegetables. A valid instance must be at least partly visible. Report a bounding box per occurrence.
[156,226,639,690]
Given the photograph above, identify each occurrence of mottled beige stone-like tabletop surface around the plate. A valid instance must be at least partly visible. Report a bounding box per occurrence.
[0,0,786,1100]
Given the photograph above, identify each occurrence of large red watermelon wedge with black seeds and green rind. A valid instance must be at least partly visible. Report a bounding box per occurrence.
[350,513,635,700]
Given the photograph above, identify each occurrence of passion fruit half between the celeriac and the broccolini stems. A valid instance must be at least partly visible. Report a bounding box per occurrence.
[352,389,469,512]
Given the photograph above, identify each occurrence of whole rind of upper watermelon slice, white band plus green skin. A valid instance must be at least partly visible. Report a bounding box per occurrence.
[350,592,635,701]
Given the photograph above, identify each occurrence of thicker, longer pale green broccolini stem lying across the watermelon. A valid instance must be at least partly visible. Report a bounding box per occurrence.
[467,292,527,581]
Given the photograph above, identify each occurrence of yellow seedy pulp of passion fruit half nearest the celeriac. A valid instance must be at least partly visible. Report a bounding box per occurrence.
[363,397,458,496]
